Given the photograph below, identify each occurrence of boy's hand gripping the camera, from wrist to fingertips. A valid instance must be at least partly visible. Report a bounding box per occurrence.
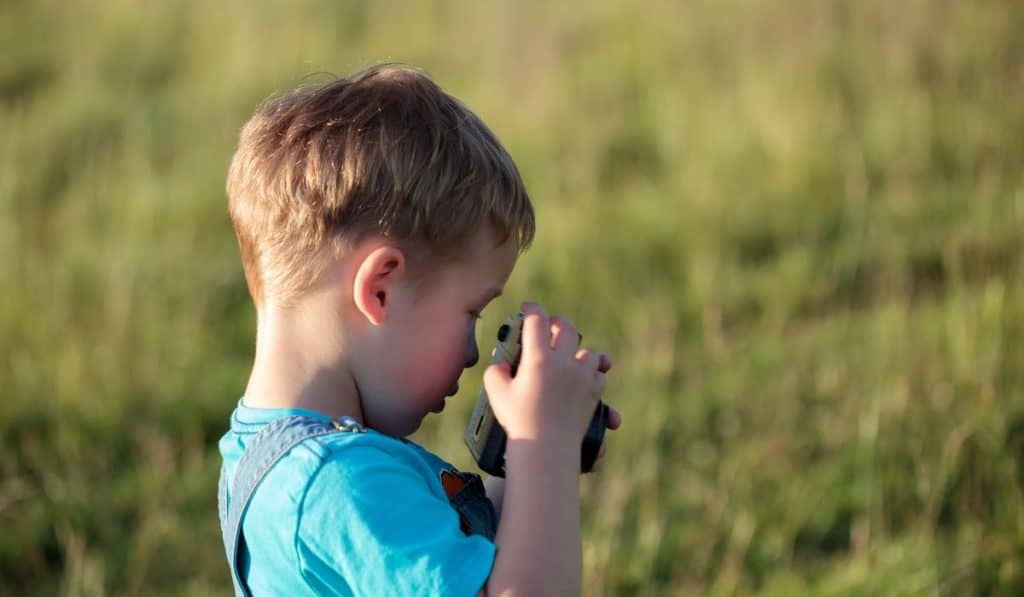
[483,302,621,447]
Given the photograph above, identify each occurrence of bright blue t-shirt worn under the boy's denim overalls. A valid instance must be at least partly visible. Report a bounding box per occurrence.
[220,400,495,595]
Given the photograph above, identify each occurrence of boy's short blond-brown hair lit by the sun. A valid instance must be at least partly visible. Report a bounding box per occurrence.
[227,65,535,306]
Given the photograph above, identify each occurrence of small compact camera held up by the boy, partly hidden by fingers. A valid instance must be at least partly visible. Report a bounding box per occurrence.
[466,313,608,477]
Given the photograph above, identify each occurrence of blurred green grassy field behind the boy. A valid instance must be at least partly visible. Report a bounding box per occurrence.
[0,0,1024,595]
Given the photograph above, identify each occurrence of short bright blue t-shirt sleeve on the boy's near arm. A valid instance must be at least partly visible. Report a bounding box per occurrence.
[296,446,495,595]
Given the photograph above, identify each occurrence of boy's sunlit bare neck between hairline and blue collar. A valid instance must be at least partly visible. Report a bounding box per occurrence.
[245,296,362,423]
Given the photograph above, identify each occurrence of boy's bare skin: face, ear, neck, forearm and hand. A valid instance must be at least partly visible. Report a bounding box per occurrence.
[245,229,622,595]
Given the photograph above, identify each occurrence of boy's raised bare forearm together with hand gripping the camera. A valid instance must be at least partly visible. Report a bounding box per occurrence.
[473,303,610,595]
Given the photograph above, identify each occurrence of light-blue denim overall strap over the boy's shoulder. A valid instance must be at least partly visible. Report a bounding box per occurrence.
[218,415,350,597]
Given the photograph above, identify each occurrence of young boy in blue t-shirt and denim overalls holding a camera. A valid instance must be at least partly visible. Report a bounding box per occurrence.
[219,66,621,595]
